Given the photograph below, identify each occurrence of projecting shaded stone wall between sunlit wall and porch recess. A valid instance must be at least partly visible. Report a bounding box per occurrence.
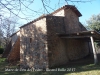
[47,16,68,67]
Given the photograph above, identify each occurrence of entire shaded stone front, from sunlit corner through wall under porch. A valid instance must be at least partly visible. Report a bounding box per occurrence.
[47,16,89,67]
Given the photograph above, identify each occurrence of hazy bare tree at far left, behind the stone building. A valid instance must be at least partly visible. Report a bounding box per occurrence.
[1,18,16,46]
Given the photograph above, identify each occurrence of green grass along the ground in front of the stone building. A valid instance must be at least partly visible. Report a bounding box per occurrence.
[0,58,100,75]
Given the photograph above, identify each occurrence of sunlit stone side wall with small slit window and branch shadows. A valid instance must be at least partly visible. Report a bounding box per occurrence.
[20,18,48,68]
